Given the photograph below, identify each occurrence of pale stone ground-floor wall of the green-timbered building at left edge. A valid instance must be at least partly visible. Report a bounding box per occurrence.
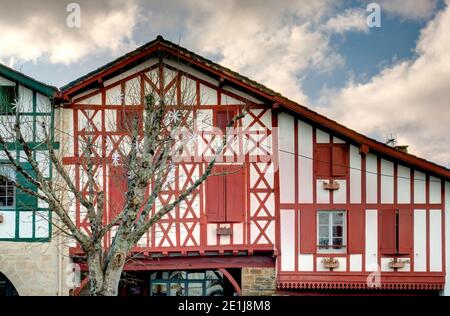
[0,241,69,296]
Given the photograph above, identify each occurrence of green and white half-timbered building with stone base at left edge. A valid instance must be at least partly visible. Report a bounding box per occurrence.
[0,64,68,296]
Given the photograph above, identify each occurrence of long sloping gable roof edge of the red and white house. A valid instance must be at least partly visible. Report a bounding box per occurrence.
[61,36,450,179]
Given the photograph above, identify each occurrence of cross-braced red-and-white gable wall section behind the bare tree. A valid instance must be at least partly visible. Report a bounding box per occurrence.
[64,55,276,262]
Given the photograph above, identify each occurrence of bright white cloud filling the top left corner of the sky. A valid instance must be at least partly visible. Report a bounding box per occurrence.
[0,0,138,64]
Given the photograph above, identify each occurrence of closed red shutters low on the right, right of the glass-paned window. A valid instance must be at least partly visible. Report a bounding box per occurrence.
[379,209,413,255]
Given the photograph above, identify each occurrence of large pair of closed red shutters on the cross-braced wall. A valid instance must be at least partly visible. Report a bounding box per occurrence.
[206,165,246,223]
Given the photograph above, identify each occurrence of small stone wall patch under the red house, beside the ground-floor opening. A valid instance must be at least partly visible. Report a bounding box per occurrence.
[241,268,276,296]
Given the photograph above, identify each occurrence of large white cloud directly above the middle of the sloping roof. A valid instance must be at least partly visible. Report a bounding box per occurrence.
[177,0,343,103]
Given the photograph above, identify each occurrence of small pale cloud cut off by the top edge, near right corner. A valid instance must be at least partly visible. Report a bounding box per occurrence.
[378,0,437,20]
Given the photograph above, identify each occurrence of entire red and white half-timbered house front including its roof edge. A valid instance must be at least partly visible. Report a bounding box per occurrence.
[62,39,450,293]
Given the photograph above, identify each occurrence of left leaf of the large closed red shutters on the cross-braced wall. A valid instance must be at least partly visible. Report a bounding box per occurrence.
[206,166,225,223]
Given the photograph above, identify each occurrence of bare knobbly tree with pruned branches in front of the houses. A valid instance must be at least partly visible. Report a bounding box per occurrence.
[0,64,247,296]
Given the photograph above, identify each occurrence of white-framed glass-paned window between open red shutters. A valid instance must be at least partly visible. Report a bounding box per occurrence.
[317,211,346,253]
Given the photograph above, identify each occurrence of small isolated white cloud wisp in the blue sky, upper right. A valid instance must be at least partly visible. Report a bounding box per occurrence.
[324,9,369,33]
